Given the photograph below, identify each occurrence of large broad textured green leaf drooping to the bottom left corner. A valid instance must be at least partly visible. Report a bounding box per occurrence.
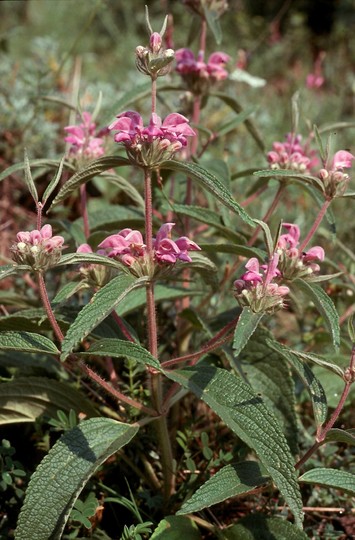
[15,418,139,540]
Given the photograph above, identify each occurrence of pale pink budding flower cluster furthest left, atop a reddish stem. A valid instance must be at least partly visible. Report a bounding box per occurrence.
[11,225,64,271]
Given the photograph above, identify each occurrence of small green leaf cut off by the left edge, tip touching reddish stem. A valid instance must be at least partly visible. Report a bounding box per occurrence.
[0,332,59,354]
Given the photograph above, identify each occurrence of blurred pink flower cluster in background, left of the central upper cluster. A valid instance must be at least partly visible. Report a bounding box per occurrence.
[64,112,104,159]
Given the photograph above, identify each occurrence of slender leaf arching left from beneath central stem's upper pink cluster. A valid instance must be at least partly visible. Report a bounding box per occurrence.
[51,156,130,208]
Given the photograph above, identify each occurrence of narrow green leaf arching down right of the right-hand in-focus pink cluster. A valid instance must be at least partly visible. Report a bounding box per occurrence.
[293,278,340,350]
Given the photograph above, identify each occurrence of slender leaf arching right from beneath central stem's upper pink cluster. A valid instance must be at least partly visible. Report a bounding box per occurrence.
[160,159,255,227]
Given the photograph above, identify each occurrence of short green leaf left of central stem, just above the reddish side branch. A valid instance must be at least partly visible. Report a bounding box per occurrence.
[78,338,161,371]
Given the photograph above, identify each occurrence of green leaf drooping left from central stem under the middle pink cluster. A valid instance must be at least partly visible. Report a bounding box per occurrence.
[61,274,147,360]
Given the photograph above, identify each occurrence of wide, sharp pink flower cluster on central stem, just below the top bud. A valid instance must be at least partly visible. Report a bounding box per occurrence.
[108,111,195,167]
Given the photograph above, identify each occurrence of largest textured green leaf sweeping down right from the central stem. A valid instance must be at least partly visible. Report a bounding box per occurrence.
[166,364,302,526]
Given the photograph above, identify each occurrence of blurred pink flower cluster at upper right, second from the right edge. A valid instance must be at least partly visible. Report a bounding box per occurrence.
[267,133,318,173]
